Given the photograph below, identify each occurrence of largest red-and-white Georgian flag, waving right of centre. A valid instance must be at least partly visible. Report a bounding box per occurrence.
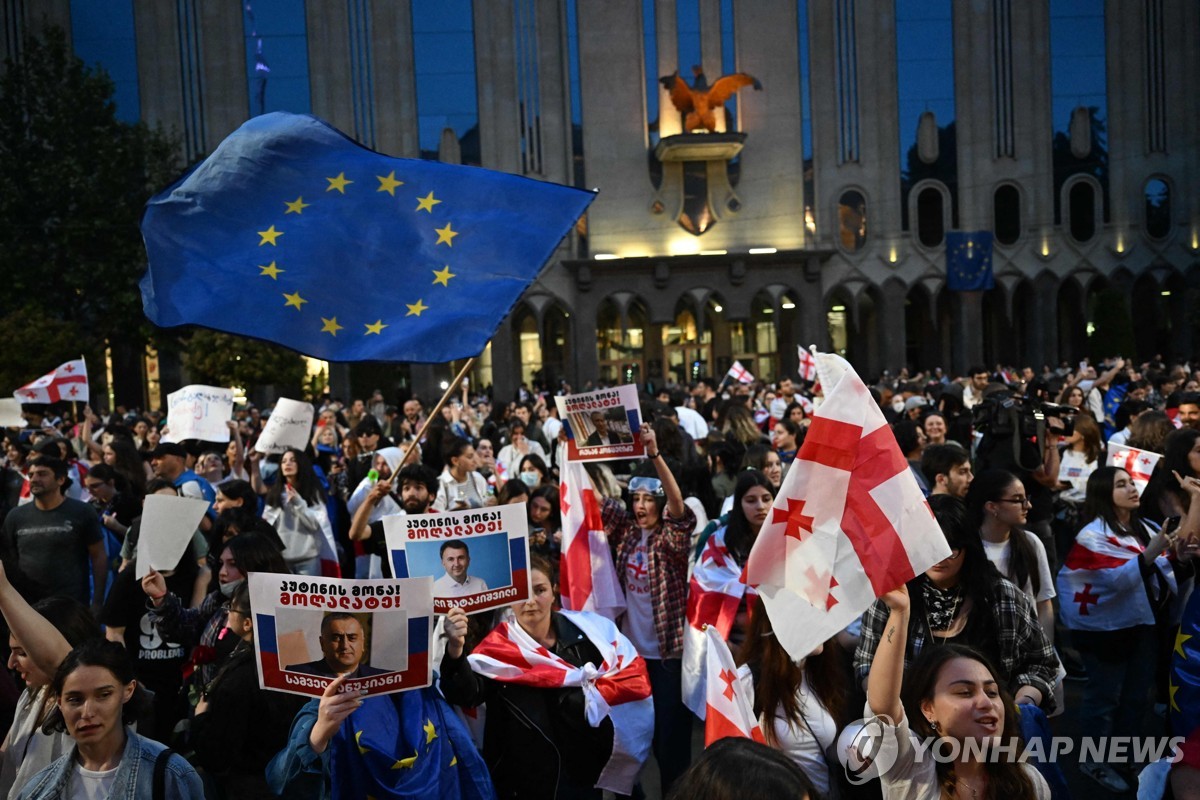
[746,353,950,660]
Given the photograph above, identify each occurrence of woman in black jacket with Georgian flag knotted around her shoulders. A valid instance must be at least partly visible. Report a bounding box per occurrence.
[440,555,654,800]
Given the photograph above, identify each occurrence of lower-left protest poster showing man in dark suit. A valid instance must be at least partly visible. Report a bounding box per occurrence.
[248,572,433,697]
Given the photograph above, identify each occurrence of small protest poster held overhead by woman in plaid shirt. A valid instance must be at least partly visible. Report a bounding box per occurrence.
[554,385,644,461]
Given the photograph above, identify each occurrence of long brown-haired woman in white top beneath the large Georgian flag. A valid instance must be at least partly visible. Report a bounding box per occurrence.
[738,597,851,798]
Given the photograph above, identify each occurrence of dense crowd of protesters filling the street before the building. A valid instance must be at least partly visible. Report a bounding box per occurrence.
[0,359,1200,800]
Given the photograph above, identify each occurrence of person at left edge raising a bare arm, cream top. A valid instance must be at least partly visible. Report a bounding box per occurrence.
[0,566,103,800]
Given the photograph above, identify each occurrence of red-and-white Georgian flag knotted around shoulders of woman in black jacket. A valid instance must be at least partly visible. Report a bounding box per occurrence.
[467,612,654,794]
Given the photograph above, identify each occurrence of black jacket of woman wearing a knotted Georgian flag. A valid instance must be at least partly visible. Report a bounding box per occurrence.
[440,614,613,800]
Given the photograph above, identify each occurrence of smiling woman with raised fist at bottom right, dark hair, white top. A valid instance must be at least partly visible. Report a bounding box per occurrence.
[866,585,1050,800]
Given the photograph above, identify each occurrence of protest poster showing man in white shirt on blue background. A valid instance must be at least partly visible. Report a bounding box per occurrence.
[383,503,530,614]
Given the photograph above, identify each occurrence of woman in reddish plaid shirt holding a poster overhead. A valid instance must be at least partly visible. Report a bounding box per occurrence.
[600,425,696,796]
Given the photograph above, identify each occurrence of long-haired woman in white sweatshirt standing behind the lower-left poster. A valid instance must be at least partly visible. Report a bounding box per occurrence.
[263,447,334,576]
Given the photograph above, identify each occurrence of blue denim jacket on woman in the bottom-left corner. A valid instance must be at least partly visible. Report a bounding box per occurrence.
[18,728,204,800]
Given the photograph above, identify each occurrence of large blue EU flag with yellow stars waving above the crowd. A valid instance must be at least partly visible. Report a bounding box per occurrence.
[142,113,594,363]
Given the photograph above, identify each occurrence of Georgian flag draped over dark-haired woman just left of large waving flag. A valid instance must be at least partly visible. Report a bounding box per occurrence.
[682,528,754,720]
